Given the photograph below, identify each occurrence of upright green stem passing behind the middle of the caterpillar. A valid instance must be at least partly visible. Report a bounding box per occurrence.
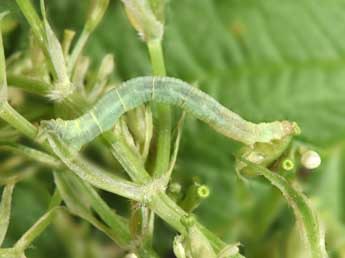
[148,40,172,177]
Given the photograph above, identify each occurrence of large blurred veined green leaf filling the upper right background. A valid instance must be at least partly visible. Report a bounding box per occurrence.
[171,0,345,145]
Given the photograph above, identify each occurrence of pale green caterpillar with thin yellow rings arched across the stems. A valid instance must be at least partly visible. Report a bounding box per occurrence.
[43,76,299,148]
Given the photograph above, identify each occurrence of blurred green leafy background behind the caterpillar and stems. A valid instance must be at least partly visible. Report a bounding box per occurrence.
[0,0,345,258]
